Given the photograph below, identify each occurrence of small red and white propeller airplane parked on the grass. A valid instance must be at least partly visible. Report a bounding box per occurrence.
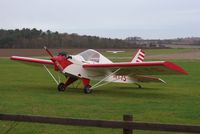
[11,47,187,94]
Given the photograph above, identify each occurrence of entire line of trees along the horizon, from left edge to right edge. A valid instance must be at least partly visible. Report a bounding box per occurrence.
[0,28,200,49]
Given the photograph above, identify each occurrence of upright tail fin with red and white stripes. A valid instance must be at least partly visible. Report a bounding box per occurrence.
[131,49,145,63]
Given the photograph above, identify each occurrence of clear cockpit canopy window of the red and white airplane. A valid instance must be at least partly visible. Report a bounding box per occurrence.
[79,50,100,62]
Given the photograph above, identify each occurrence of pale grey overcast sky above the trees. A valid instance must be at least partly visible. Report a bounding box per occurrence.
[0,0,200,39]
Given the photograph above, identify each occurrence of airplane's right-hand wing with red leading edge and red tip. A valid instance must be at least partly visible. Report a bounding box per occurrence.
[83,61,187,76]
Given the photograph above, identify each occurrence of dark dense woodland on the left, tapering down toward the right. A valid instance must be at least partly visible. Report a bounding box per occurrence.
[0,28,138,48]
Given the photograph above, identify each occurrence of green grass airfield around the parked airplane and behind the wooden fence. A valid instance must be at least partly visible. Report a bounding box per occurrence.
[0,49,200,134]
